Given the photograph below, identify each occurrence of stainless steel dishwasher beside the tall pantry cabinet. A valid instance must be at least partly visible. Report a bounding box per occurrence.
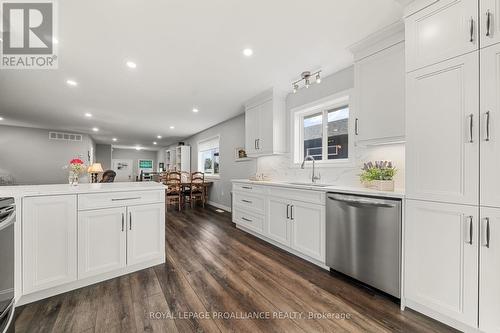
[326,193,401,298]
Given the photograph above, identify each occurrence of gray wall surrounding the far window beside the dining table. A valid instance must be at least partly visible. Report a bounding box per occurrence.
[171,114,256,207]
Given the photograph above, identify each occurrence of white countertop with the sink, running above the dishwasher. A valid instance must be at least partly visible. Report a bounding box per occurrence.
[232,179,405,199]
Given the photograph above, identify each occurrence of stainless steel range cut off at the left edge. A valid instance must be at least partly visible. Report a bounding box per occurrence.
[0,198,16,333]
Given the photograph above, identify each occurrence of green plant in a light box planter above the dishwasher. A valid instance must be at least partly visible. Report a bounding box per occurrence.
[360,161,397,191]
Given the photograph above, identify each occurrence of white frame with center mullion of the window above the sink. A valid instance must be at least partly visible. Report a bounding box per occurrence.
[290,89,355,168]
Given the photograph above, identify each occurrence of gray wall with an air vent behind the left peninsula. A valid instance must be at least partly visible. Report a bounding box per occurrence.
[0,125,95,185]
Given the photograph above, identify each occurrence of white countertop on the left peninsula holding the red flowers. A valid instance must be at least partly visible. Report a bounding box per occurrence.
[0,182,166,197]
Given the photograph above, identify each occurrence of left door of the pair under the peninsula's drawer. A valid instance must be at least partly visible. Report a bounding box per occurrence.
[78,207,127,279]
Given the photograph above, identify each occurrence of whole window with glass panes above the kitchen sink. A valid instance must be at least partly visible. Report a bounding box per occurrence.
[293,94,352,164]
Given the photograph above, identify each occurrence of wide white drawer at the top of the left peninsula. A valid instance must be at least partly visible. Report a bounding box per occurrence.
[78,191,165,210]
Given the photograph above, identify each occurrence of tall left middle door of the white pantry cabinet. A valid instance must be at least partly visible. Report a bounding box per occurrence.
[406,52,479,205]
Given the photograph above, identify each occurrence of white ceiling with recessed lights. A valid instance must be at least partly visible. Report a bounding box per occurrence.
[0,0,402,146]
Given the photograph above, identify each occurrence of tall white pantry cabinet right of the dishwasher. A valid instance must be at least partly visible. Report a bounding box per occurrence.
[404,0,500,332]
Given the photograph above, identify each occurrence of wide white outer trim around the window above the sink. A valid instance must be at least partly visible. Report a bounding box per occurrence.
[289,89,355,168]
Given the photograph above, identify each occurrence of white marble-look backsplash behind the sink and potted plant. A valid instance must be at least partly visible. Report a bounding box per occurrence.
[257,144,405,189]
